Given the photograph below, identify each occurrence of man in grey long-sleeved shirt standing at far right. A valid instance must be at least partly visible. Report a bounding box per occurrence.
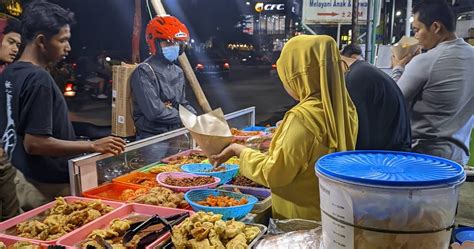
[392,0,474,164]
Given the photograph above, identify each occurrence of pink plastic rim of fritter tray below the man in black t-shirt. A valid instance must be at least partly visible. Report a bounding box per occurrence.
[0,196,124,245]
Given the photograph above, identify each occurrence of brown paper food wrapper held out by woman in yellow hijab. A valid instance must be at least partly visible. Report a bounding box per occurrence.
[179,105,233,157]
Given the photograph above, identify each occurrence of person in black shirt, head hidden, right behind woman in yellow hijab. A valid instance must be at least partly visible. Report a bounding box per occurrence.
[341,51,411,151]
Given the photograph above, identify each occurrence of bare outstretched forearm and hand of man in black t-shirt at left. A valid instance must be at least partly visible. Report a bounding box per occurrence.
[23,133,125,157]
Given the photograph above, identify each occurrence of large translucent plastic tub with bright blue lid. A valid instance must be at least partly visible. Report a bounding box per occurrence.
[316,151,466,249]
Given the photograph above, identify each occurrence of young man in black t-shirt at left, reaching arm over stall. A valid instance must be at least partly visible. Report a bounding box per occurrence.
[0,1,125,210]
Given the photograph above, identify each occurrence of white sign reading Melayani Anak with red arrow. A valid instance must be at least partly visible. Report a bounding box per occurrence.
[303,0,368,24]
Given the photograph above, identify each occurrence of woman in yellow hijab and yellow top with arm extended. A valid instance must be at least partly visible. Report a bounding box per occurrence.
[211,35,358,220]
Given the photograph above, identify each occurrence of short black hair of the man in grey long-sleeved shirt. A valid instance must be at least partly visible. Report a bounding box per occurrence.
[413,0,456,32]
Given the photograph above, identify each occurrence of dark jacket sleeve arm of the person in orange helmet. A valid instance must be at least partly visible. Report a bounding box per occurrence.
[131,64,181,124]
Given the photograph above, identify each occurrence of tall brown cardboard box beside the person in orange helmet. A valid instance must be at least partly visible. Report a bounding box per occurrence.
[112,64,136,137]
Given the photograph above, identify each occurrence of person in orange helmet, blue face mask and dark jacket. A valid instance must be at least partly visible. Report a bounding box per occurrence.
[130,16,196,139]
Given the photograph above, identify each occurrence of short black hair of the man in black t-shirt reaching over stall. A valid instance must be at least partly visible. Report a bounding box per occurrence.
[21,0,75,43]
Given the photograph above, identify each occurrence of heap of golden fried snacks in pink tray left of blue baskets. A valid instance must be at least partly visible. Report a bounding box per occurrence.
[126,187,188,208]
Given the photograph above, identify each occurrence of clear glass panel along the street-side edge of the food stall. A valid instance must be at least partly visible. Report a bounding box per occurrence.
[69,107,255,196]
